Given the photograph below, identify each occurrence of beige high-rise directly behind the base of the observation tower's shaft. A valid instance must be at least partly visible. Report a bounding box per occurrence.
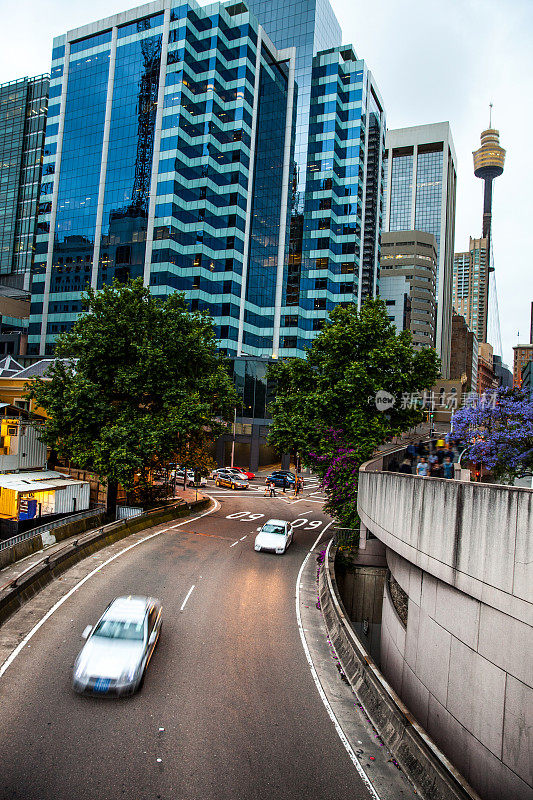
[452,237,489,342]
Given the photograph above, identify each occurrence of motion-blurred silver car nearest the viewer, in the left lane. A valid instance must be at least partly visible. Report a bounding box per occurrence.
[73,595,161,695]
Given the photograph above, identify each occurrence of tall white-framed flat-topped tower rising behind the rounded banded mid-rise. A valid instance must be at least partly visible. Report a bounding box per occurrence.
[384,122,457,378]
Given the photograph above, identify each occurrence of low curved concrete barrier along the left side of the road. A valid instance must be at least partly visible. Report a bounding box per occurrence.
[0,498,212,625]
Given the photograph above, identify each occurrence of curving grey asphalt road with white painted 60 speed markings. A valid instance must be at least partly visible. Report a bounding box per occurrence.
[0,491,370,800]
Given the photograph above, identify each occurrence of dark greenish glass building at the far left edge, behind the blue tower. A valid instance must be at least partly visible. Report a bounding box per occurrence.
[0,75,49,289]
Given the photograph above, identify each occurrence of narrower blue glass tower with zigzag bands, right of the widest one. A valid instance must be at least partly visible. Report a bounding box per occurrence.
[298,47,385,349]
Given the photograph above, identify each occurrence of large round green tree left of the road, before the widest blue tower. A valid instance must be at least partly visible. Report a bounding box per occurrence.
[28,279,236,507]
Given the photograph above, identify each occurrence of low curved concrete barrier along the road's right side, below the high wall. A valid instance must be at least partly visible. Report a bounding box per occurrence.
[318,540,481,800]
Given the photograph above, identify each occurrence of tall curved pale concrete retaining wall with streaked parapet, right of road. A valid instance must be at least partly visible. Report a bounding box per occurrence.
[358,472,533,800]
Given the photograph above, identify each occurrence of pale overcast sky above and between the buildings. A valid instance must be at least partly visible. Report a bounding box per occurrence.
[0,0,533,364]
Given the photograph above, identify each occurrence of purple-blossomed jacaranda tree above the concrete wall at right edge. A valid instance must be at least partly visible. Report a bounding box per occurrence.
[453,387,533,483]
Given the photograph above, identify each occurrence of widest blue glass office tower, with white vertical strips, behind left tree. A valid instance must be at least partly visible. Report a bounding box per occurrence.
[29,0,295,356]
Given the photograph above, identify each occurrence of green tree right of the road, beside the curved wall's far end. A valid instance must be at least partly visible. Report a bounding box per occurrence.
[269,299,440,522]
